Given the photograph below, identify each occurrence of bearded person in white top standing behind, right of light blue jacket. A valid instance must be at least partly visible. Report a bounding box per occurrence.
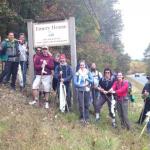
[90,62,102,113]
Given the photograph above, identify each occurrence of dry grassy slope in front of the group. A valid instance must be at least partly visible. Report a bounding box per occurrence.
[0,79,150,150]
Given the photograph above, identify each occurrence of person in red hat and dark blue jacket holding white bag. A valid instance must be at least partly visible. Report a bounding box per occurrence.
[54,54,73,111]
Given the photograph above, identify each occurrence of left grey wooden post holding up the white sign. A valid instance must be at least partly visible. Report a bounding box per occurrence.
[27,19,35,84]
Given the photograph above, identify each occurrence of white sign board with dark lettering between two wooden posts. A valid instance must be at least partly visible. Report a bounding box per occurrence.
[33,20,70,47]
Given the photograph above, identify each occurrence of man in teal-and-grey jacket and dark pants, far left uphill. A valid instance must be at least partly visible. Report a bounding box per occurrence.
[0,32,20,90]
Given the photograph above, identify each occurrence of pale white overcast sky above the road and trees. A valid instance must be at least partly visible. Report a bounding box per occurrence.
[117,0,150,60]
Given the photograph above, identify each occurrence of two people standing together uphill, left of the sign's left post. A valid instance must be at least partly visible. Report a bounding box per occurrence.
[0,32,28,90]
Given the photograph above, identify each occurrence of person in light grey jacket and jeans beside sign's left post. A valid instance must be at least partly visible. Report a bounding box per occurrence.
[19,33,28,88]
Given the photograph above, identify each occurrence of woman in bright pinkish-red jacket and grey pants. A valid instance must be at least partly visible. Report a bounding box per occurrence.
[108,72,131,130]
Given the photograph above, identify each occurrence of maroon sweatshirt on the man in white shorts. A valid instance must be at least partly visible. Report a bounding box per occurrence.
[33,54,54,75]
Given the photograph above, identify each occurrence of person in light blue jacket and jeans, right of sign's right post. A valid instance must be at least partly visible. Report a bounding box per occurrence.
[74,60,93,123]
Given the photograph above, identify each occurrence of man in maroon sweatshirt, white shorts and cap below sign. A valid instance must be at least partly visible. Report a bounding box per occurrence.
[29,46,54,109]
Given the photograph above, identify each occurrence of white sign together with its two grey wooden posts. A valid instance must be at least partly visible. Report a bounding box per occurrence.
[27,17,77,110]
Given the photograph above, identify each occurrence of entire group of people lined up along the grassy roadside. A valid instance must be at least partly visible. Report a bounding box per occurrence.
[0,32,150,130]
